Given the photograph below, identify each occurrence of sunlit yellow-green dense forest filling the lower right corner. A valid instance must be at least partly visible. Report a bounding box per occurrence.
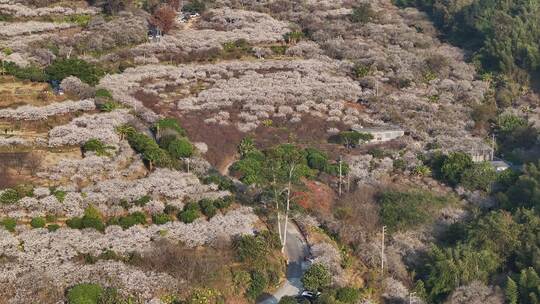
[416,164,540,304]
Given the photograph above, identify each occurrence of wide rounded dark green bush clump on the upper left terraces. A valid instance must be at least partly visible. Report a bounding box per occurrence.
[45,58,104,86]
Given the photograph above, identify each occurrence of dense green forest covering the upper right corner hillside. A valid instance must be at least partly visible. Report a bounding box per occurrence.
[395,0,540,84]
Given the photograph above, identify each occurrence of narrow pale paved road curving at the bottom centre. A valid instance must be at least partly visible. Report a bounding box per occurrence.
[259,222,309,304]
